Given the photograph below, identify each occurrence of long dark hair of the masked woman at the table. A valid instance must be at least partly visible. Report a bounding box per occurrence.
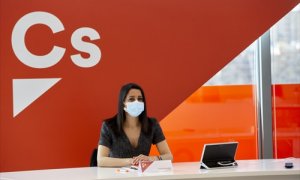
[116,83,151,134]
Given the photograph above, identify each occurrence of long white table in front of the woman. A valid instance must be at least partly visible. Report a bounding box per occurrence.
[0,158,300,180]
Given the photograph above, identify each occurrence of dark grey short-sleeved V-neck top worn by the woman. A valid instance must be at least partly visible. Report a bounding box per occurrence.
[99,118,165,158]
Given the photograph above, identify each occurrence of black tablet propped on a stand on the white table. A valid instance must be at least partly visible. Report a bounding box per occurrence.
[200,142,238,169]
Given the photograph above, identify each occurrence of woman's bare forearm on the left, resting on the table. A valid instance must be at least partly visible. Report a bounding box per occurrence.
[97,145,133,167]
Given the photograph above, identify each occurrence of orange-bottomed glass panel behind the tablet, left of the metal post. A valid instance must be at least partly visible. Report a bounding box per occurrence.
[152,43,258,162]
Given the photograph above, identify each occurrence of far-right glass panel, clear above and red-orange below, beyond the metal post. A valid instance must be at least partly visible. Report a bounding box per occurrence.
[271,5,300,158]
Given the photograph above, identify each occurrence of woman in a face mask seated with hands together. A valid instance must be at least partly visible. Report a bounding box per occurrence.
[97,83,173,167]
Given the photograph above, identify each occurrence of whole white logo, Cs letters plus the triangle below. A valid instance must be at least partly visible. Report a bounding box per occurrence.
[11,12,101,117]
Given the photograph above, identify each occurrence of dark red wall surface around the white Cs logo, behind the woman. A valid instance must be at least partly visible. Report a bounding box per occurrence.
[0,0,299,171]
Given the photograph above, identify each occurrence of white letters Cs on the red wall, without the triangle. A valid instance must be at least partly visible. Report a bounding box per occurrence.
[11,12,101,68]
